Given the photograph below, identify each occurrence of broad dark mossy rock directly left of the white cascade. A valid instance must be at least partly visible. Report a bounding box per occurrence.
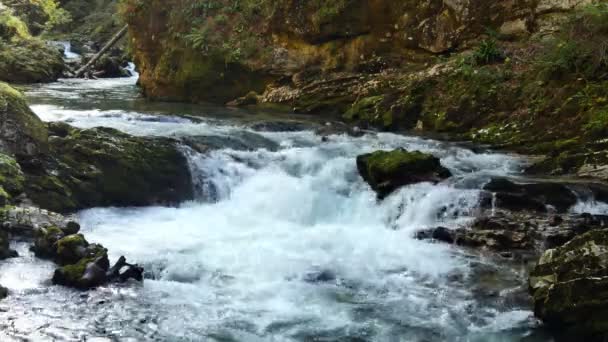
[20,127,192,212]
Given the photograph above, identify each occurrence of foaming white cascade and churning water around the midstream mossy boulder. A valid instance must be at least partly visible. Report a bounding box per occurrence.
[71,128,529,341]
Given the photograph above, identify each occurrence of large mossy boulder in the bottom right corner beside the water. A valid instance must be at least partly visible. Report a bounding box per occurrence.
[529,230,608,340]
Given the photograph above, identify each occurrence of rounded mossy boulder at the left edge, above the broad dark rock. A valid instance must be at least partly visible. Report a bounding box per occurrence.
[0,83,48,156]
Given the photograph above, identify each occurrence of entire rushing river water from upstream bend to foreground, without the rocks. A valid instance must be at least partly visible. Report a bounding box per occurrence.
[0,73,604,341]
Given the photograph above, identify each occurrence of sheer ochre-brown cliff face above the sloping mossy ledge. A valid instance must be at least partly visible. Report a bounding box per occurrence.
[123,0,593,102]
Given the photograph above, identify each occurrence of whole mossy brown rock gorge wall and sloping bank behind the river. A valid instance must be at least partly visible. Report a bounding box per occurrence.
[122,0,608,179]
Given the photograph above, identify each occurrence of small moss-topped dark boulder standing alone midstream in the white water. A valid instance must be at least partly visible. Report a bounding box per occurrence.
[357,149,451,198]
